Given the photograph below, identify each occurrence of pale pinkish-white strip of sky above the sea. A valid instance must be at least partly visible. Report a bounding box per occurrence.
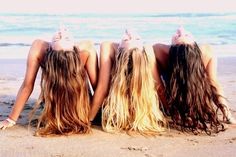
[0,0,236,14]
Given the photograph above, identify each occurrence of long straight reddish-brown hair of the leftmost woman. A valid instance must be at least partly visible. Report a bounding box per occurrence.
[31,48,90,136]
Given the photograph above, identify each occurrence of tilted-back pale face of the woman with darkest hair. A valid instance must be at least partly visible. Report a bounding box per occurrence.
[171,27,195,45]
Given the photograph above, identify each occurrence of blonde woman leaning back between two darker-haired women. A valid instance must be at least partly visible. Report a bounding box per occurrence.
[90,31,166,135]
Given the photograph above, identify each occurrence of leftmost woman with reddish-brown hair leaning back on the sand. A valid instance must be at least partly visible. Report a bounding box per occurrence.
[0,28,98,136]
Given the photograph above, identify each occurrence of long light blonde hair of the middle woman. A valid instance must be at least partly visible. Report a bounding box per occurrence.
[102,45,166,135]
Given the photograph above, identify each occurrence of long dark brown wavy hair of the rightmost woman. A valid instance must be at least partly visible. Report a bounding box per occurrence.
[167,43,226,134]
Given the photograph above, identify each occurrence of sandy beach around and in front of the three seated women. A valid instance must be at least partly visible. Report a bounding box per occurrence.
[0,57,236,157]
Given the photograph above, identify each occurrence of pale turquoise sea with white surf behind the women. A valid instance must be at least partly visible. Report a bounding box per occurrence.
[0,13,236,58]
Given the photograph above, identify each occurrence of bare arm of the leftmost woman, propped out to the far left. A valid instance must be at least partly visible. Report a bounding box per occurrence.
[0,40,48,128]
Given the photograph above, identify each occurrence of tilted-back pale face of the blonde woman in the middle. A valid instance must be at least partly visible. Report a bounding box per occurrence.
[119,29,143,49]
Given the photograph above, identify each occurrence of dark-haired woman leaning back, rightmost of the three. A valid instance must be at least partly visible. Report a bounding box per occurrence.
[153,28,235,134]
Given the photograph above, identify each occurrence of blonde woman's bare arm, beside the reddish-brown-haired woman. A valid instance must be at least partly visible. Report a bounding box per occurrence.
[89,42,115,121]
